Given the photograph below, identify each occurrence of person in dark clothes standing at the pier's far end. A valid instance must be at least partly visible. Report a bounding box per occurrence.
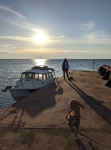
[62,58,69,80]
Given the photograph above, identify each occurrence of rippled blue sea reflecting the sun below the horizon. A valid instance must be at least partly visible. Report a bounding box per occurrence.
[0,59,111,110]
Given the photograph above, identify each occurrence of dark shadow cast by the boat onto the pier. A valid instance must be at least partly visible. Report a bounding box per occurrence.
[0,82,63,124]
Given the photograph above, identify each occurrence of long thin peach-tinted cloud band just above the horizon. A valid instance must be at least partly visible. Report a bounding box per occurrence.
[0,47,110,57]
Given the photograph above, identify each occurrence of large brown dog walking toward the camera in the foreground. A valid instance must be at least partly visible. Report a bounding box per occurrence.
[66,99,84,139]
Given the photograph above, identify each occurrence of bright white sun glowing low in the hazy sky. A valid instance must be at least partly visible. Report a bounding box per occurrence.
[33,31,49,45]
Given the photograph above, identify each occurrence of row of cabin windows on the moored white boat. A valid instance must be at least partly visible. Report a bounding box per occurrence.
[21,72,53,80]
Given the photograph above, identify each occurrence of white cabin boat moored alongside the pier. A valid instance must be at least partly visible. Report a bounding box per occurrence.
[2,66,56,101]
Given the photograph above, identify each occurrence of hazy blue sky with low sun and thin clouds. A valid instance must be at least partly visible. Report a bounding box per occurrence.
[0,0,111,59]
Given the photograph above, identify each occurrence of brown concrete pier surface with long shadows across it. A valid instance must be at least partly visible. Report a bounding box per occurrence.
[0,71,111,150]
